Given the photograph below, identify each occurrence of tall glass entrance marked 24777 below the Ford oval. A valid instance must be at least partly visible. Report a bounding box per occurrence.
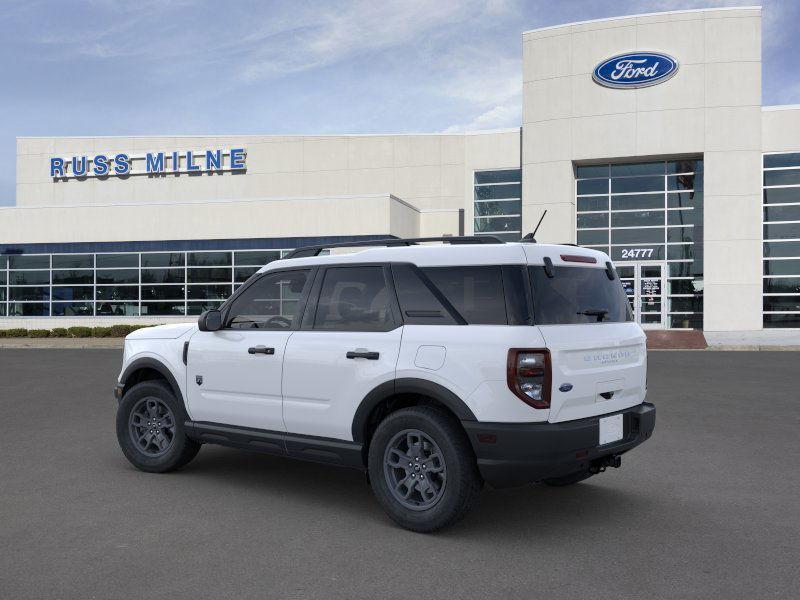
[575,159,703,328]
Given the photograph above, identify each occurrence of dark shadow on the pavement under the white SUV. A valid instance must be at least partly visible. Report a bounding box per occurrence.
[122,446,654,540]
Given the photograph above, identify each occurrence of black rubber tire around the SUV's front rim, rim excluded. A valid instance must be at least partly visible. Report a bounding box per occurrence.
[117,380,201,473]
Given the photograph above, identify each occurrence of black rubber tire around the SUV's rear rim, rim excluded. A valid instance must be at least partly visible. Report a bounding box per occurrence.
[368,406,483,533]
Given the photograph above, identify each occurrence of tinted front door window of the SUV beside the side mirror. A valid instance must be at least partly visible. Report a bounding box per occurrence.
[227,271,309,329]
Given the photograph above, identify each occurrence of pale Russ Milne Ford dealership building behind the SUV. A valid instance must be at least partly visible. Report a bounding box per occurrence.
[0,7,800,332]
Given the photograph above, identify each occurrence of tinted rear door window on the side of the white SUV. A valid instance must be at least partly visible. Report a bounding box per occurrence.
[314,267,395,331]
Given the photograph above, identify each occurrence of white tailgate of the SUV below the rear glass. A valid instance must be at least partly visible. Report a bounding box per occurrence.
[539,322,647,423]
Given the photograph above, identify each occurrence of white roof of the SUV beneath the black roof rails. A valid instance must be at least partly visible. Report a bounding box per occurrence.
[261,243,610,271]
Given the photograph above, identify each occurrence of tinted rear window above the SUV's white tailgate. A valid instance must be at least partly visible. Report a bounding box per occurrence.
[529,266,633,325]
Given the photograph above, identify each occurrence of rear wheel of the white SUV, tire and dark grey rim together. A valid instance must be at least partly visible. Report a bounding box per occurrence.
[369,406,482,532]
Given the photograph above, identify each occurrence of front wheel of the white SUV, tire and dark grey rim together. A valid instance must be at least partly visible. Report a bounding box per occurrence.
[117,380,200,473]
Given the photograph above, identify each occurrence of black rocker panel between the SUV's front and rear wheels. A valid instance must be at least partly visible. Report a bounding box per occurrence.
[184,421,364,470]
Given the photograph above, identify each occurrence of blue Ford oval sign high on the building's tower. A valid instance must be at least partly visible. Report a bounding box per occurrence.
[592,52,678,88]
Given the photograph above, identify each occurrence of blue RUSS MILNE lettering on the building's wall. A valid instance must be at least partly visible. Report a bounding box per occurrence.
[50,148,247,179]
